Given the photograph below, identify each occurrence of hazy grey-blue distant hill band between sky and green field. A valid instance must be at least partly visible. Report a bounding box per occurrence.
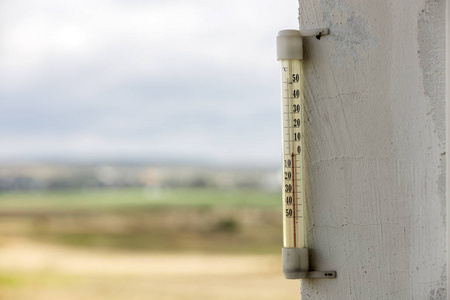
[0,162,281,191]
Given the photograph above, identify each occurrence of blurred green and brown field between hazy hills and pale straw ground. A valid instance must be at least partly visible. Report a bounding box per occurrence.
[0,188,281,254]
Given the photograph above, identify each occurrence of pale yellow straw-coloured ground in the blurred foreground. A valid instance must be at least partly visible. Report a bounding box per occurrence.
[0,238,299,300]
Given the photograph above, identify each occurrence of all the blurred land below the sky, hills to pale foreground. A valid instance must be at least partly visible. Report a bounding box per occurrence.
[0,164,298,299]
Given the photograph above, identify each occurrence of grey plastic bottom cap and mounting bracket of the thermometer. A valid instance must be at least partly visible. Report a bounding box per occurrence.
[281,248,336,279]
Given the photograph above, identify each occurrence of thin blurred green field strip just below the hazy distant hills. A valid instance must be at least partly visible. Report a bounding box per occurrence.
[0,188,281,212]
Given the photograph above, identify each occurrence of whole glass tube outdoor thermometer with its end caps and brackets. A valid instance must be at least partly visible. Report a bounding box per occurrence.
[277,29,336,279]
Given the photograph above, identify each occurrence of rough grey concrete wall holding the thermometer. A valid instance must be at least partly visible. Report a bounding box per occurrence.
[299,0,448,300]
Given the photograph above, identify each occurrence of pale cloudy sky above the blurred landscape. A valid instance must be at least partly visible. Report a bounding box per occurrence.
[0,0,298,167]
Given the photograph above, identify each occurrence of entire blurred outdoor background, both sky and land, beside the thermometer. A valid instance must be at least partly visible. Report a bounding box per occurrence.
[0,0,299,300]
